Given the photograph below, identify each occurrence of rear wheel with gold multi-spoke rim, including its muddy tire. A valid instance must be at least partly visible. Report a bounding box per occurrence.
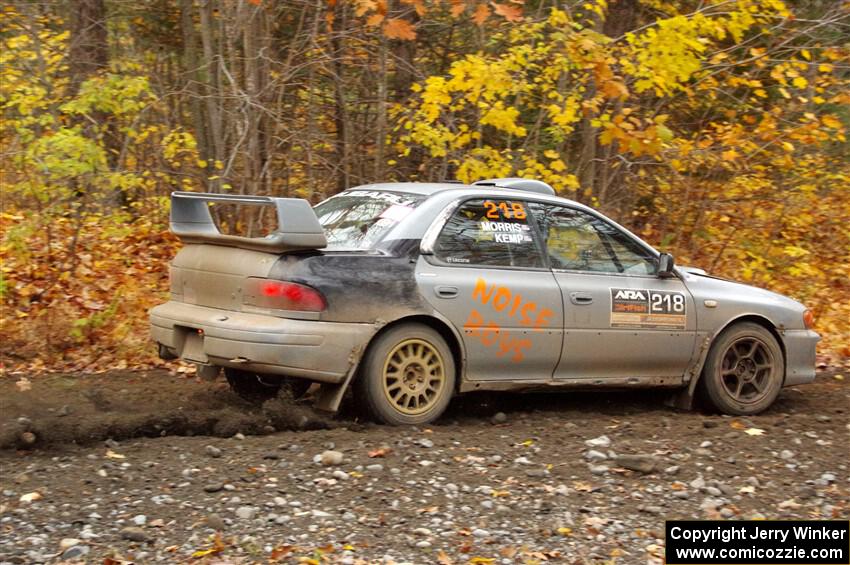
[354,323,455,426]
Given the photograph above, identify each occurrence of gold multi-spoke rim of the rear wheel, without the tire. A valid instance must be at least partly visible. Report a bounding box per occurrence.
[383,338,446,416]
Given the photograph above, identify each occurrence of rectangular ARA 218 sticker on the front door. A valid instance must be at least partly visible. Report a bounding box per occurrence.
[611,288,687,330]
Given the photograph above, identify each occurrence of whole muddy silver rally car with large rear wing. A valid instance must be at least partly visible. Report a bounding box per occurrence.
[150,178,819,425]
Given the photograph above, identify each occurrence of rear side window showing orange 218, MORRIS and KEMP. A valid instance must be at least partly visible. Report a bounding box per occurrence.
[434,198,543,268]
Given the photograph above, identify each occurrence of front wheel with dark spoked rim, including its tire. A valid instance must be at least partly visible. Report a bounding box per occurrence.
[700,322,785,416]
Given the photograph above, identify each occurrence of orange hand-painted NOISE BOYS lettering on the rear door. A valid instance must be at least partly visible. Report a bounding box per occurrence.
[463,277,555,362]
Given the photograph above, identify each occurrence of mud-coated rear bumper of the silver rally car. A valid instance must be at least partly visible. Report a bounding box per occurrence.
[150,302,376,383]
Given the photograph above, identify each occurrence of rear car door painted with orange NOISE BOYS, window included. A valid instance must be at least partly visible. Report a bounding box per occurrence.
[416,198,563,381]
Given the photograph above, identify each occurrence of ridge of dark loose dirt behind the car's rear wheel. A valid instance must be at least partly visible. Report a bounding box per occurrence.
[0,371,336,449]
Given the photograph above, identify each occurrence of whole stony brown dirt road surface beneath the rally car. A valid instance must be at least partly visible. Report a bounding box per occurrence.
[0,370,850,564]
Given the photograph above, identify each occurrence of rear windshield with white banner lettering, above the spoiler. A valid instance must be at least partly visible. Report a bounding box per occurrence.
[314,190,425,249]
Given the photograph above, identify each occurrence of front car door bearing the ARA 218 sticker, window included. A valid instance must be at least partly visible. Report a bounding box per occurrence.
[529,203,696,382]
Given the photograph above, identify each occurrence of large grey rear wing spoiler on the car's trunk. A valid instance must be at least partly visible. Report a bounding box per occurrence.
[171,191,328,253]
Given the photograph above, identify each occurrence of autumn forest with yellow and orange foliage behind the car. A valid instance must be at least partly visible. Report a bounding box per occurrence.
[0,0,850,371]
